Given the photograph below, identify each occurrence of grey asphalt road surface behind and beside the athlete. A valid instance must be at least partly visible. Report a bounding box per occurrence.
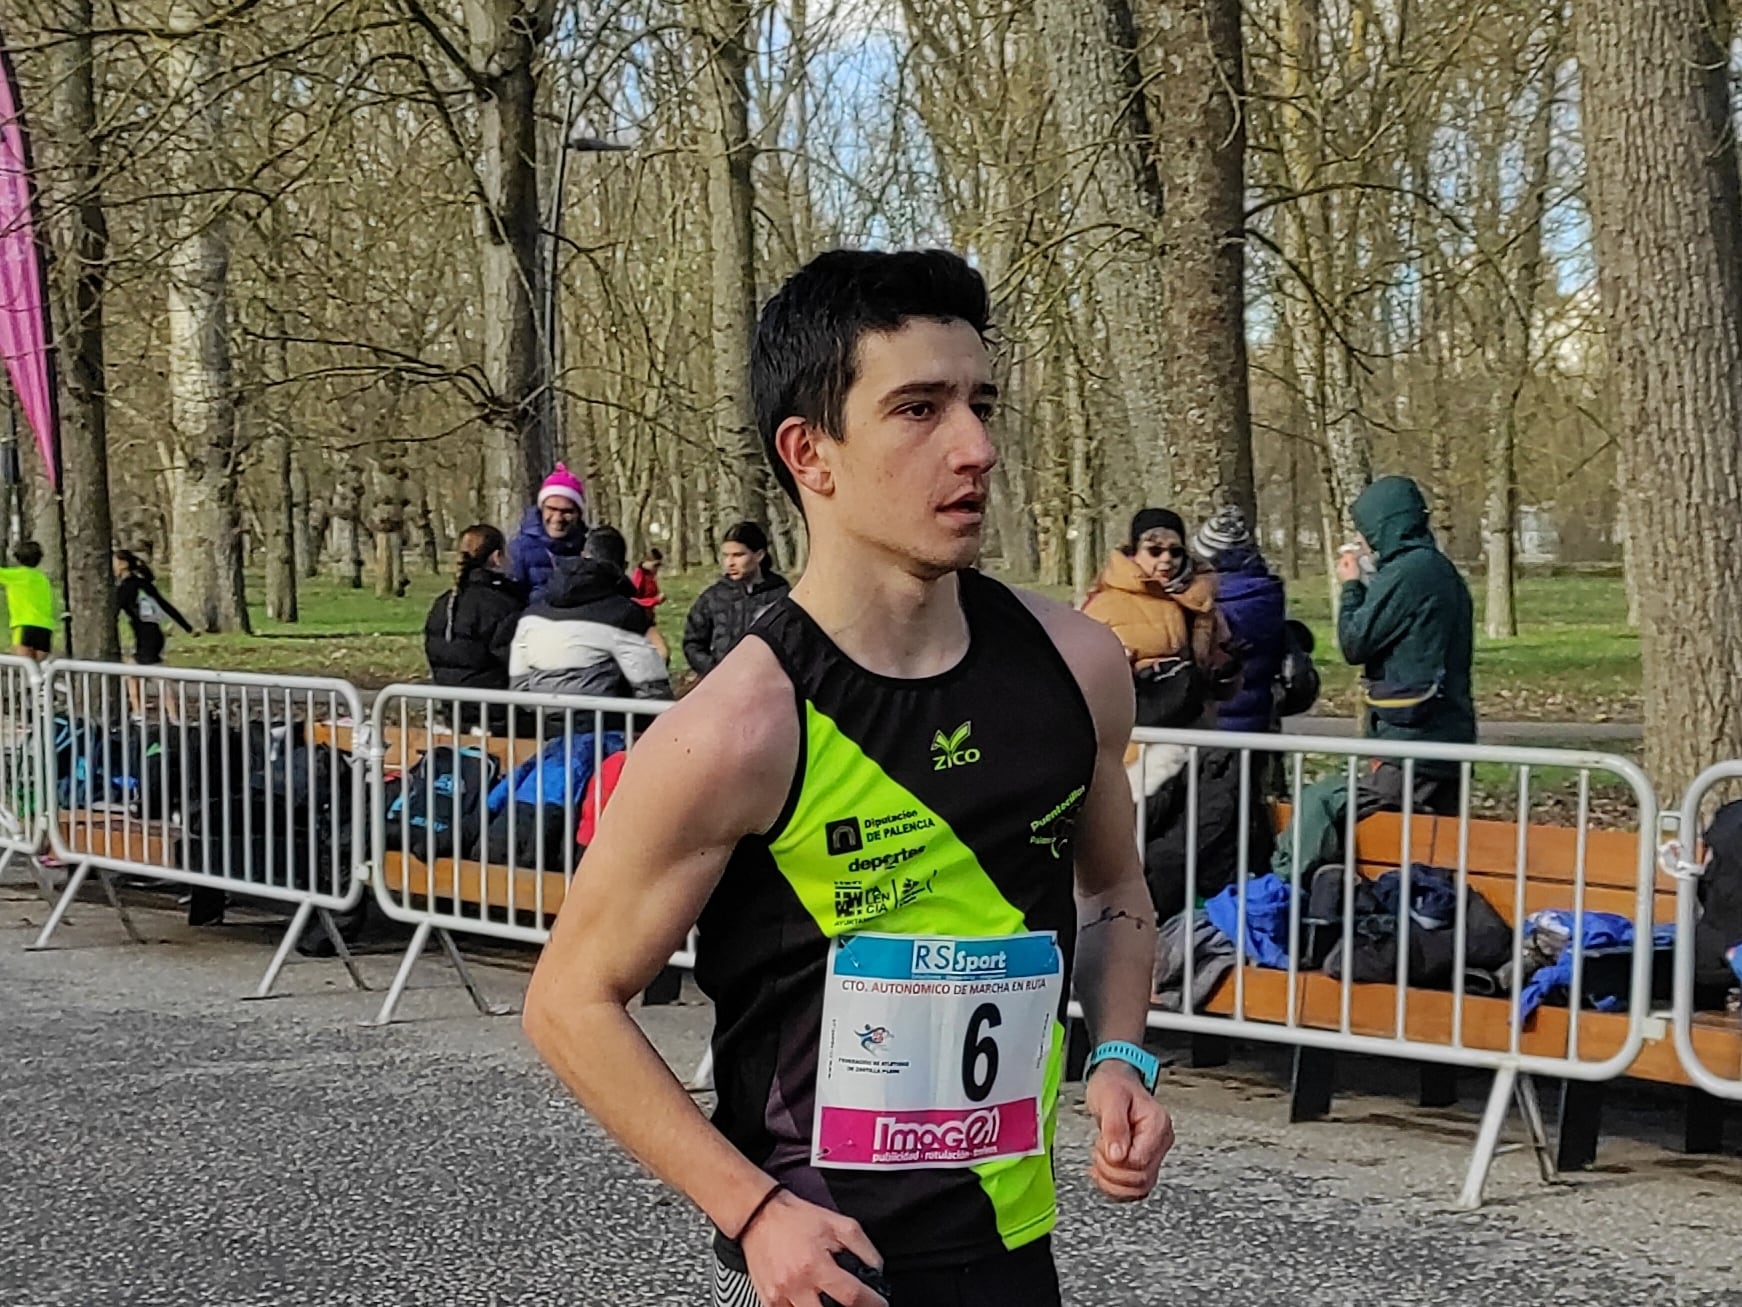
[0,889,1742,1307]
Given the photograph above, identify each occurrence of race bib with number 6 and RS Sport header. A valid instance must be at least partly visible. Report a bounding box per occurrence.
[810,931,1064,1171]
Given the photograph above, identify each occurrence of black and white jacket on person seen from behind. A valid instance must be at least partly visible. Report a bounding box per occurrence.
[509,558,671,699]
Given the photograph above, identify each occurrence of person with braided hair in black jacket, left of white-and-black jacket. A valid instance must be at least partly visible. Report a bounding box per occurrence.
[423,523,526,727]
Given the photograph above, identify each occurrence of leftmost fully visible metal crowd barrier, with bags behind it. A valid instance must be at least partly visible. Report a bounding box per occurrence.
[30,660,368,999]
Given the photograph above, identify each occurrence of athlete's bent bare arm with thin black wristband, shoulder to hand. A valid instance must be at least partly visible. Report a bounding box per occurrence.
[523,640,881,1307]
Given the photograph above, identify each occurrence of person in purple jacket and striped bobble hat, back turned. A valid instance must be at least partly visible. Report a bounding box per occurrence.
[1192,505,1287,734]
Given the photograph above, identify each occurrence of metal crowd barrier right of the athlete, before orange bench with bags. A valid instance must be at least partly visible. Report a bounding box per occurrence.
[1131,730,1658,1206]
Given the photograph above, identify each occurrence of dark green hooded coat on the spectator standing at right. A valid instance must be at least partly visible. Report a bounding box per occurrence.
[1336,476,1475,752]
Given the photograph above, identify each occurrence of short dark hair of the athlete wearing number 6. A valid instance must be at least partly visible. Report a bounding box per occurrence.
[751,249,991,504]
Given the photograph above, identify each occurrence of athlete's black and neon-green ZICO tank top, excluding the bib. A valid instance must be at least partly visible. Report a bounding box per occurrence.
[695,572,1096,1269]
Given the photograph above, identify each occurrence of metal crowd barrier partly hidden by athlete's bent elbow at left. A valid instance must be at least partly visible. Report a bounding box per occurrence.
[369,685,672,1023]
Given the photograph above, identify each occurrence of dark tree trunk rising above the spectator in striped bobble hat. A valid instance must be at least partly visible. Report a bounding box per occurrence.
[1144,0,1258,526]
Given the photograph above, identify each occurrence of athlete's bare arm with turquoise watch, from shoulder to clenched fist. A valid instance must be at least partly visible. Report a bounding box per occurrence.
[1024,596,1174,1201]
